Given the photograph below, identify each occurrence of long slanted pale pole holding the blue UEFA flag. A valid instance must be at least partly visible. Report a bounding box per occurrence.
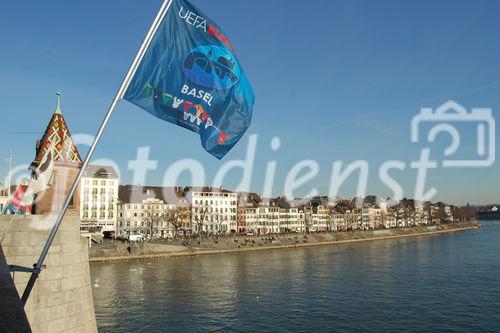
[21,0,174,305]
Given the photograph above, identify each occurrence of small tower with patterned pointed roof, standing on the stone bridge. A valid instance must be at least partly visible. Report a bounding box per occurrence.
[33,91,83,215]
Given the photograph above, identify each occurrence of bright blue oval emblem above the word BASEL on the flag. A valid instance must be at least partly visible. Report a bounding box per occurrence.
[183,45,241,90]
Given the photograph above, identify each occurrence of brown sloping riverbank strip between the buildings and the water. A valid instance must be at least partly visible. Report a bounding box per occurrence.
[89,222,480,262]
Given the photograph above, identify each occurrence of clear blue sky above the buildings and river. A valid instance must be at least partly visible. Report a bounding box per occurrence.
[0,0,500,203]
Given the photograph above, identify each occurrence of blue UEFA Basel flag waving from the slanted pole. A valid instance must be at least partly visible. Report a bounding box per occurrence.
[123,0,255,159]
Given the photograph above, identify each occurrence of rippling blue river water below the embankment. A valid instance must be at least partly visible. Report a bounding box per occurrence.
[90,221,500,333]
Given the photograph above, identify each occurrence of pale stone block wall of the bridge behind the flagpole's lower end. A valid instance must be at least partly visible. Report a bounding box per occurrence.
[0,211,97,333]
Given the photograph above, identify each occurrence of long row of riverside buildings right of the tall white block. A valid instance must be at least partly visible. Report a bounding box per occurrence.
[109,186,473,237]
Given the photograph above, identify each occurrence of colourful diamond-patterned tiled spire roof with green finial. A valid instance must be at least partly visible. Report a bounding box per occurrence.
[34,91,82,165]
